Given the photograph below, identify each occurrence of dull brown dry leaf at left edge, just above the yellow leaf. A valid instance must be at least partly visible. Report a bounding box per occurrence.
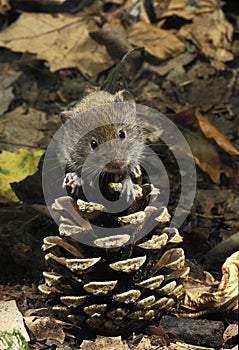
[0,106,61,151]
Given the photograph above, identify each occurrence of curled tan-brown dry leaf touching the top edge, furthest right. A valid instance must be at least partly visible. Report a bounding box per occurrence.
[152,0,233,69]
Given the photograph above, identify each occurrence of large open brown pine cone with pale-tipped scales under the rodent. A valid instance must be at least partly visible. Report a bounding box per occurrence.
[39,178,189,335]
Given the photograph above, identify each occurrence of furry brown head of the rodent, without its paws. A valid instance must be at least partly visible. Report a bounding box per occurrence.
[60,92,143,178]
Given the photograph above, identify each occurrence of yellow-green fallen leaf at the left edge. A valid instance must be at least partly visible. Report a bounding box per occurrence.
[0,149,44,202]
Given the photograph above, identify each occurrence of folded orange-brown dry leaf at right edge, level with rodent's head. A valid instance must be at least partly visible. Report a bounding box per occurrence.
[171,109,239,184]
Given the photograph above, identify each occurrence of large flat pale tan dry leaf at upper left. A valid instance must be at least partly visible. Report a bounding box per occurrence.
[0,13,113,77]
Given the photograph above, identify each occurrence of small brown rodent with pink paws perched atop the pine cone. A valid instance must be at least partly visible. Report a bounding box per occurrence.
[61,90,144,201]
